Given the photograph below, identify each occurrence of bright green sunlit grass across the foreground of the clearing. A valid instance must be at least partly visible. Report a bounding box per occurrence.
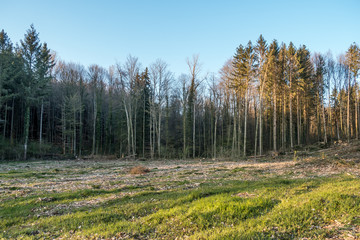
[0,175,360,239]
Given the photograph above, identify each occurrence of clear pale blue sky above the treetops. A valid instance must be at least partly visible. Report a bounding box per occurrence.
[0,0,360,75]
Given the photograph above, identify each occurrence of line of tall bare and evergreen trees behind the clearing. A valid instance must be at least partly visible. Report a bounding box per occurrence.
[0,26,360,159]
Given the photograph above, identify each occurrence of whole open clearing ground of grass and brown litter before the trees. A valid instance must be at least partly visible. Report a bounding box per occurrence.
[0,141,360,239]
